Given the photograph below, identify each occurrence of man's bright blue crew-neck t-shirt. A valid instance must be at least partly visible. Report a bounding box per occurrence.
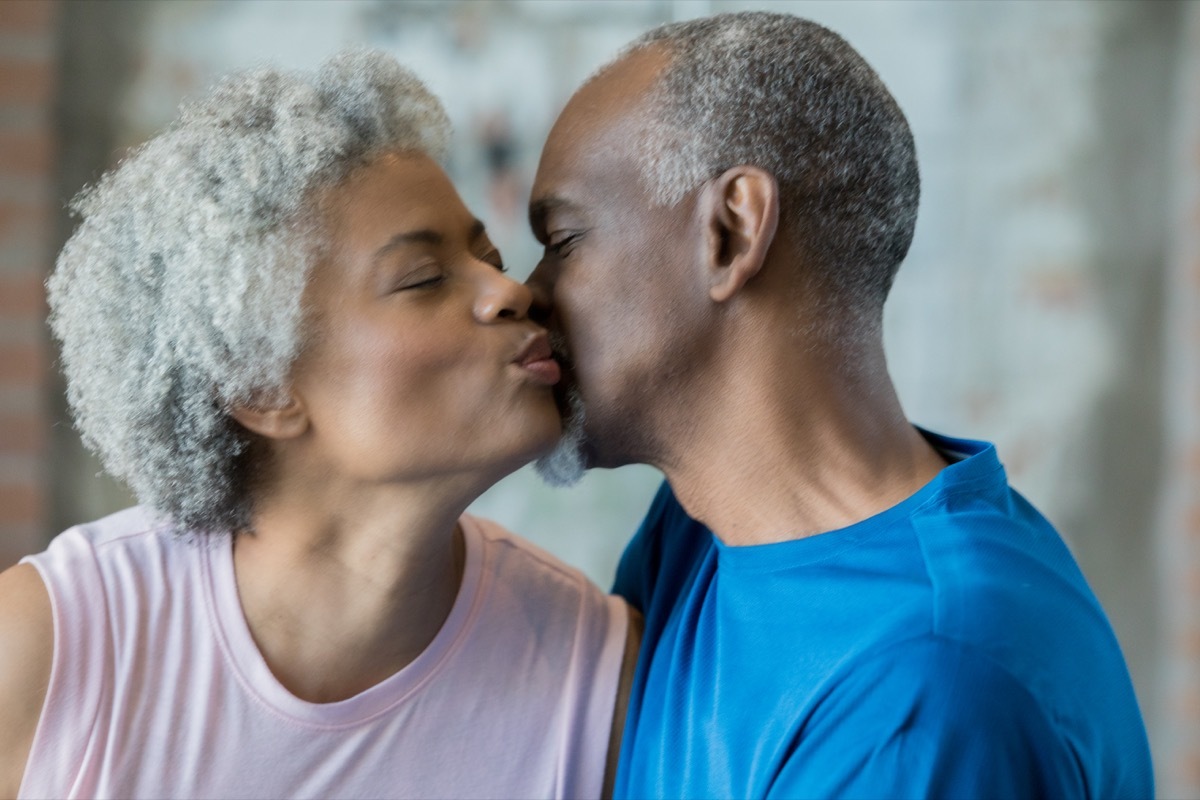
[616,434,1153,799]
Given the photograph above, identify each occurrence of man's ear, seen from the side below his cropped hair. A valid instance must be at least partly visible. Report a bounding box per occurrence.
[702,166,779,302]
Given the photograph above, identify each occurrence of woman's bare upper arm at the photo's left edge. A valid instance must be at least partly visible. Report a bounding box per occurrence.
[0,564,54,798]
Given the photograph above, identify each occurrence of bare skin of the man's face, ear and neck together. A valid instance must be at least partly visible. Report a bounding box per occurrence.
[529,46,944,545]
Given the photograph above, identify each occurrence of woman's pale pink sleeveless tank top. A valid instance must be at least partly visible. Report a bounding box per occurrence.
[19,507,626,800]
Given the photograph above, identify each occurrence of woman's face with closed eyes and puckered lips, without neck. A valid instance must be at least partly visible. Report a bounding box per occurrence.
[254,148,558,483]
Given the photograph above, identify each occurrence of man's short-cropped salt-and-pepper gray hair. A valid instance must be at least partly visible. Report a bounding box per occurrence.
[623,12,920,330]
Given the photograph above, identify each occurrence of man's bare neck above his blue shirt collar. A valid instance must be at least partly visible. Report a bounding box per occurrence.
[659,340,946,545]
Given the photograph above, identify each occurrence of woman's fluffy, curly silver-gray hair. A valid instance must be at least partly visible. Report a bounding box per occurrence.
[47,50,449,530]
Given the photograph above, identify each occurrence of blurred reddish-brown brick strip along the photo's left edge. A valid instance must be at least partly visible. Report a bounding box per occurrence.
[0,0,58,569]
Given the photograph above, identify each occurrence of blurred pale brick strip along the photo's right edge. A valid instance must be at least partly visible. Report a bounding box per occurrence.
[1157,4,1200,798]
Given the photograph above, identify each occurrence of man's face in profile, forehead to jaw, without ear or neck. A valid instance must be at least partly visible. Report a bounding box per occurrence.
[528,48,713,467]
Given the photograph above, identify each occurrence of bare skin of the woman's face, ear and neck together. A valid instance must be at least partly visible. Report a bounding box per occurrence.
[226,155,559,702]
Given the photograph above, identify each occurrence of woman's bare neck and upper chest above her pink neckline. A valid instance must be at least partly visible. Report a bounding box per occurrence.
[234,486,469,702]
